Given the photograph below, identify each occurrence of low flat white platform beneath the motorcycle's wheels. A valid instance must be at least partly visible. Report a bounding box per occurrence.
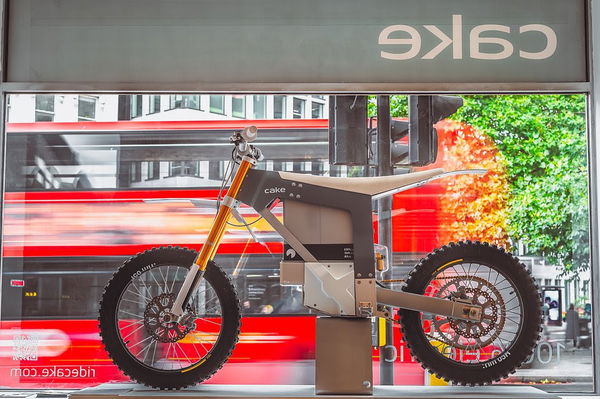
[69,384,559,399]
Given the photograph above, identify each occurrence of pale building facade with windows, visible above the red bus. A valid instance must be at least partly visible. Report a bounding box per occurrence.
[7,94,327,123]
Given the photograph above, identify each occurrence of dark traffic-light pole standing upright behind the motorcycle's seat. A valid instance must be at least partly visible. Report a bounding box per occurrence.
[377,96,396,385]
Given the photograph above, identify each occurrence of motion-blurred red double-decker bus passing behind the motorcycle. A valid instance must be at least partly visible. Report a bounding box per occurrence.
[0,120,444,388]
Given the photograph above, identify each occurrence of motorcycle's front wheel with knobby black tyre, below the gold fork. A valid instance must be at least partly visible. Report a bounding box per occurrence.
[99,247,240,389]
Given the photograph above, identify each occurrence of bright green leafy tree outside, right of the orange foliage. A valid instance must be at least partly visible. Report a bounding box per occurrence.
[453,95,589,273]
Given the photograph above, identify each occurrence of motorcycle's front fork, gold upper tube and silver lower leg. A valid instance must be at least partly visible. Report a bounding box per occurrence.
[169,156,256,321]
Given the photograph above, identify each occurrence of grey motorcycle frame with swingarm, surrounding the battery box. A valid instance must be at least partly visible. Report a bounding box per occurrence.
[237,169,481,320]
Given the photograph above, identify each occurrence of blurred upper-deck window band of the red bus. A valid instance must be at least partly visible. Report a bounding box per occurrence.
[5,122,328,191]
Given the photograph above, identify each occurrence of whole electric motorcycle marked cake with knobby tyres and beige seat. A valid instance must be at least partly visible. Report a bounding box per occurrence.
[99,127,542,389]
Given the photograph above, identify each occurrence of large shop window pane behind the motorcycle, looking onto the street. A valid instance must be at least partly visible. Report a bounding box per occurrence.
[0,94,596,394]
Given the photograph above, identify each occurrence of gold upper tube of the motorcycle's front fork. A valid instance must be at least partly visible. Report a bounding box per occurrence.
[194,159,252,271]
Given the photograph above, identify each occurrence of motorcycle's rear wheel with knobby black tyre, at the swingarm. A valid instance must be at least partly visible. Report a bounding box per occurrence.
[399,241,542,385]
